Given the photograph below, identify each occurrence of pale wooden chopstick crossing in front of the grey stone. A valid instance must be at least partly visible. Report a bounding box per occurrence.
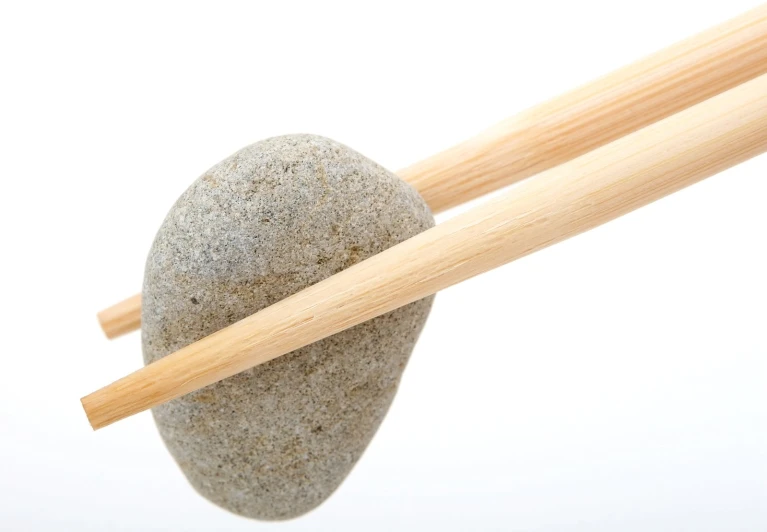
[82,75,767,428]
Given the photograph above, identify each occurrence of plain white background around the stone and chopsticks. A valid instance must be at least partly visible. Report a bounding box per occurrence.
[0,0,767,532]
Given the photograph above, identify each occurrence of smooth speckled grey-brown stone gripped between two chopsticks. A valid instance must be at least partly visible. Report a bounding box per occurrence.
[141,135,434,520]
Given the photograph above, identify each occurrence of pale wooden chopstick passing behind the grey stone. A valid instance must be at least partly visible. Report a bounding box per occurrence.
[97,5,767,333]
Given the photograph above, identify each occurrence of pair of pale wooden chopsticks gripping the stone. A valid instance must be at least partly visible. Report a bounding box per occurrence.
[82,2,767,429]
